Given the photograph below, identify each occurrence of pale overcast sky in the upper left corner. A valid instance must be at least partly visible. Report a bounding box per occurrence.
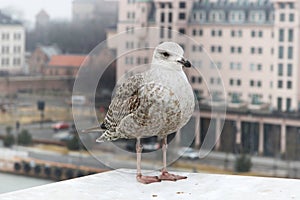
[0,0,73,22]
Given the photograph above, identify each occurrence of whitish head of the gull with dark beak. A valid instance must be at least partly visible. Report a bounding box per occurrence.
[152,42,192,70]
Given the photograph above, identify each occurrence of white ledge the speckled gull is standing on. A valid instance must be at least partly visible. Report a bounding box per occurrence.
[0,169,300,200]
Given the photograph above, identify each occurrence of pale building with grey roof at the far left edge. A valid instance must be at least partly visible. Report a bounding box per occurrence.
[0,10,25,74]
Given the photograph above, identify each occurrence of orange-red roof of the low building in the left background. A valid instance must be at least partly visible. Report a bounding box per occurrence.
[48,55,87,67]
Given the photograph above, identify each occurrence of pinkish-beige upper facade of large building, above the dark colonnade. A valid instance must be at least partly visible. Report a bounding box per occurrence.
[109,0,300,112]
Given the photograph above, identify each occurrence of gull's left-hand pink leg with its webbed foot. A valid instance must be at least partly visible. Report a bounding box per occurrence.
[136,138,161,184]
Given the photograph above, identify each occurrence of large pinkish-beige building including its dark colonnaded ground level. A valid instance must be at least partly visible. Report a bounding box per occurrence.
[108,0,300,160]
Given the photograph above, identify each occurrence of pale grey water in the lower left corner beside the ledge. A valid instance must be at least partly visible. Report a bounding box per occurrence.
[0,173,54,194]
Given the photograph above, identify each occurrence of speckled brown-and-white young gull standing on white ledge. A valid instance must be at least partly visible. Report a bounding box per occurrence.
[83,42,195,184]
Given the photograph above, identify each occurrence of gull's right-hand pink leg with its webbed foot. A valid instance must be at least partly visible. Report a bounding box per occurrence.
[159,137,187,181]
